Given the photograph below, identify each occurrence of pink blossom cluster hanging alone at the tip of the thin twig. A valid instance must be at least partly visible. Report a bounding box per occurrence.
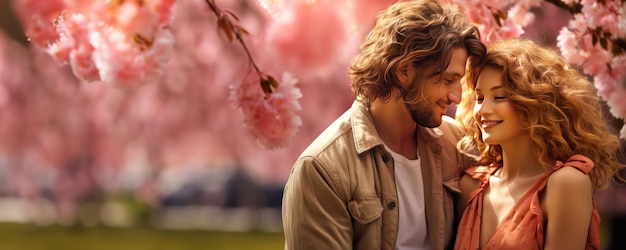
[230,70,302,149]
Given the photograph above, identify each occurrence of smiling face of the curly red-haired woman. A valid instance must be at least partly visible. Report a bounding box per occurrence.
[474,66,528,145]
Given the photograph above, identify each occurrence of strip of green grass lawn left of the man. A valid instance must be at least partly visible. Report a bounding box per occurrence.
[0,223,284,250]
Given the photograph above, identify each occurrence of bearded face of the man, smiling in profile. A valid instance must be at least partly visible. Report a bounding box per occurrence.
[406,48,467,128]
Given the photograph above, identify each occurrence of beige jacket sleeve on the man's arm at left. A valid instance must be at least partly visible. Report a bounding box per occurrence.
[282,157,352,250]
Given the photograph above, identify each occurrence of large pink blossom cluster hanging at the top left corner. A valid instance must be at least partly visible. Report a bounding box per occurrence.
[13,0,176,84]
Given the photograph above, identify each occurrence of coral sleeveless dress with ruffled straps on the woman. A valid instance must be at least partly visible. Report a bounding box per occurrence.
[454,155,600,250]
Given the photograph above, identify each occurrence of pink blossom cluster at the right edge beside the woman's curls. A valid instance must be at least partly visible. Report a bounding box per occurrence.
[557,0,626,138]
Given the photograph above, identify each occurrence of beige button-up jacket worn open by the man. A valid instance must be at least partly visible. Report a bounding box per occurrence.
[282,101,471,250]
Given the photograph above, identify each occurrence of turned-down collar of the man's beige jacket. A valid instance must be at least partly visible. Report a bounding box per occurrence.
[350,100,442,154]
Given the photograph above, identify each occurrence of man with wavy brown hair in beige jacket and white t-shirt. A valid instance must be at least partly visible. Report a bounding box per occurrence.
[282,0,486,250]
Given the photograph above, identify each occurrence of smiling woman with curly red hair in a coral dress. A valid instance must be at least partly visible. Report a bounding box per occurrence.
[455,39,621,250]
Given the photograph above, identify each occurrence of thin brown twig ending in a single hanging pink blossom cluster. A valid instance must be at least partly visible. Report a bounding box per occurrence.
[205,0,302,149]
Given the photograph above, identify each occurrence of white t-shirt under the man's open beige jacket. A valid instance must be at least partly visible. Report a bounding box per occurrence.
[385,145,432,250]
